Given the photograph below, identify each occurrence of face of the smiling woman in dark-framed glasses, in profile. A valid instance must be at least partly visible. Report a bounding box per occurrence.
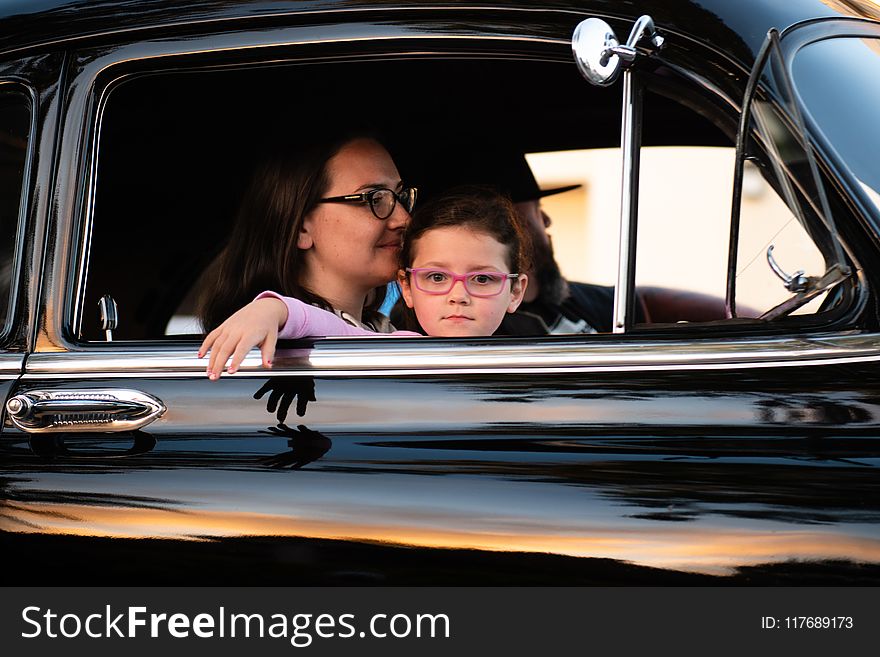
[297,139,409,309]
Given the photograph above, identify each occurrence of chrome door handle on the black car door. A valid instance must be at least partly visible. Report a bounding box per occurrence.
[6,390,165,433]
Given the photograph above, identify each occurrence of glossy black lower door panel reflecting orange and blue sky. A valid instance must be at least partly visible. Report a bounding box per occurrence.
[3,366,880,584]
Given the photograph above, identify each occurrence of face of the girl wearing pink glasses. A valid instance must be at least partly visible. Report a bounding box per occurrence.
[398,226,528,337]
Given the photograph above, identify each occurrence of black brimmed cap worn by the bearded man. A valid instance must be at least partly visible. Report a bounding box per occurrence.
[420,148,581,203]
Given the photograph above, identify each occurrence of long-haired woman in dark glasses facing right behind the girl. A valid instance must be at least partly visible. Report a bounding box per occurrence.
[202,133,415,374]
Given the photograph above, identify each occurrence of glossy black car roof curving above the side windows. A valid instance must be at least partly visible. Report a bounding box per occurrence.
[0,0,880,60]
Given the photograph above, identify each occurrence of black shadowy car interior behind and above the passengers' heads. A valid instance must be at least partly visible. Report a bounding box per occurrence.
[80,56,736,341]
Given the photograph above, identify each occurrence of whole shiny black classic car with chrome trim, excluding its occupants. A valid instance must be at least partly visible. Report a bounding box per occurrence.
[0,0,880,584]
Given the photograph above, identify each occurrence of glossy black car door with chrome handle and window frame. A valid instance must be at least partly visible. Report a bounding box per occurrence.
[4,9,880,583]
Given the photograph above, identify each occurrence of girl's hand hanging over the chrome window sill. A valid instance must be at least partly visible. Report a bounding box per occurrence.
[199,297,287,381]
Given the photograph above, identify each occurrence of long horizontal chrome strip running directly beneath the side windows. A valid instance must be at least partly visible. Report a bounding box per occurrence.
[24,334,880,379]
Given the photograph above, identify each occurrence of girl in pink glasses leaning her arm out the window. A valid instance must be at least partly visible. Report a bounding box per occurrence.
[199,187,528,379]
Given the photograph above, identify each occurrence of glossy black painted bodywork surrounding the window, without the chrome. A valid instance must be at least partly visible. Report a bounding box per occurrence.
[0,0,880,584]
